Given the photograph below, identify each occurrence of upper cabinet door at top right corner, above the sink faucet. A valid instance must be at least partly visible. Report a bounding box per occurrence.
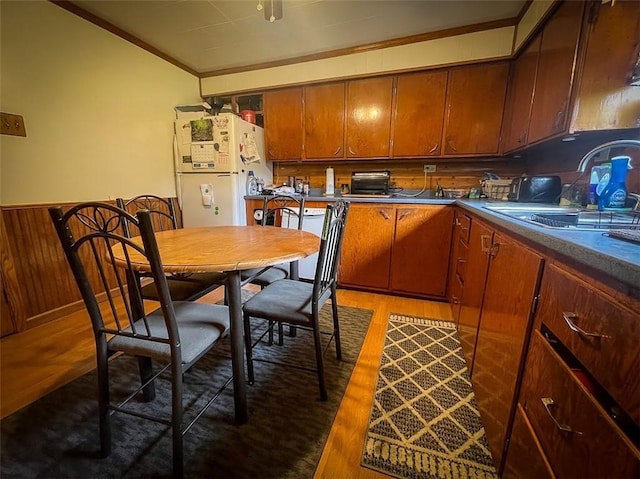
[570,1,640,132]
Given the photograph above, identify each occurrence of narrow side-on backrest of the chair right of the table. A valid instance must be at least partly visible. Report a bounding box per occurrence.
[313,200,349,308]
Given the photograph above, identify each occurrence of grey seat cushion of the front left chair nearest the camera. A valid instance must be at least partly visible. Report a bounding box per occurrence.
[109,301,229,369]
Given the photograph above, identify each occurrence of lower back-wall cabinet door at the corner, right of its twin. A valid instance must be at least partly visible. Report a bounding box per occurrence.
[390,205,453,297]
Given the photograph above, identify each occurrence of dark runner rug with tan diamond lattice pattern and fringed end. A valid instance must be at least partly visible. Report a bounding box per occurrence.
[362,314,497,479]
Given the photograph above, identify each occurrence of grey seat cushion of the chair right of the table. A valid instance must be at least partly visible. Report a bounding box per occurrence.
[243,279,330,325]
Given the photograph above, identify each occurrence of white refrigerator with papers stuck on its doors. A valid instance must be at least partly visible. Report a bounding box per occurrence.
[174,113,273,227]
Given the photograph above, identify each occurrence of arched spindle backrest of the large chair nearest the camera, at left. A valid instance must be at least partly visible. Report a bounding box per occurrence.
[49,202,180,358]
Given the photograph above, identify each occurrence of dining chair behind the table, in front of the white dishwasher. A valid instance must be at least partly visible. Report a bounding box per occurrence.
[240,195,305,346]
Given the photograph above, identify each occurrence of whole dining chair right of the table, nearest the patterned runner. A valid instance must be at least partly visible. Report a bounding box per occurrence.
[243,200,349,401]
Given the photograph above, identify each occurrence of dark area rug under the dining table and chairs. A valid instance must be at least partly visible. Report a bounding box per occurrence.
[0,304,372,479]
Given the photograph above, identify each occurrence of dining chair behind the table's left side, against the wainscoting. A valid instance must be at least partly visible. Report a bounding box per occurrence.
[116,195,226,301]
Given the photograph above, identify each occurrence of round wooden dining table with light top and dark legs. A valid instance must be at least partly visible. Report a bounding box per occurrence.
[116,226,320,424]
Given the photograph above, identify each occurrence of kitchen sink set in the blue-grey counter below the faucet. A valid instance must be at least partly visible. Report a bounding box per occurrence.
[484,205,640,231]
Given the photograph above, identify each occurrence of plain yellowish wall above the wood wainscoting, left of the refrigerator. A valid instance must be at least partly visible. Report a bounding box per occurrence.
[0,0,200,205]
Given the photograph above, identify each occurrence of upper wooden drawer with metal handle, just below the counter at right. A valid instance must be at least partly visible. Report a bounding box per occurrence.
[538,265,640,424]
